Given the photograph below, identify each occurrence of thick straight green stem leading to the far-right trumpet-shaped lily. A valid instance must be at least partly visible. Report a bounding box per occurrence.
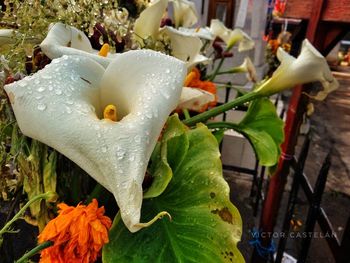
[182,92,261,126]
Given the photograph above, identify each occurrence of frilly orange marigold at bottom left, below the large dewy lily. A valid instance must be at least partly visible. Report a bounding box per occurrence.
[39,199,112,263]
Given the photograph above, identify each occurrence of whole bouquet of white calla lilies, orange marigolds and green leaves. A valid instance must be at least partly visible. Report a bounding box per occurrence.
[0,0,337,262]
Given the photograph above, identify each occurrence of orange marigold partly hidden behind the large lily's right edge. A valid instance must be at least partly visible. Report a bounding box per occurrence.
[184,68,217,112]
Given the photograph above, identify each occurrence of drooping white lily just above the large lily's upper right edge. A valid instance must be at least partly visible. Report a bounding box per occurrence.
[161,26,210,70]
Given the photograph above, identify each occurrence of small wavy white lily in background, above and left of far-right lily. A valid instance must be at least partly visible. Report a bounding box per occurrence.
[210,19,254,52]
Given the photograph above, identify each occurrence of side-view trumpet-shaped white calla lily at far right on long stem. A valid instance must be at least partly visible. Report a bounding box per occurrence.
[255,39,339,100]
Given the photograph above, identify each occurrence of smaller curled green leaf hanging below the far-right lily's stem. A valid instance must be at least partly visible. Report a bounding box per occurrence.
[233,98,284,166]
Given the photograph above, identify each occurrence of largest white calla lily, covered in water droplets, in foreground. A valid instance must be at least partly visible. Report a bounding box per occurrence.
[5,50,186,232]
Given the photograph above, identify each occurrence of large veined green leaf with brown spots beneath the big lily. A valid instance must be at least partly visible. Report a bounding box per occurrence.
[103,116,244,263]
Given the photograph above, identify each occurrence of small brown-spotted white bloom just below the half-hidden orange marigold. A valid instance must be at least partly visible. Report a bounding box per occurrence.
[177,87,215,111]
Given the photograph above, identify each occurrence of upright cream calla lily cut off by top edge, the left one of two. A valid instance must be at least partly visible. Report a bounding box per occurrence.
[134,0,168,44]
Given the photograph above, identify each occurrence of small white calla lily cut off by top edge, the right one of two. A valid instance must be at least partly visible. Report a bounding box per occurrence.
[171,0,198,28]
